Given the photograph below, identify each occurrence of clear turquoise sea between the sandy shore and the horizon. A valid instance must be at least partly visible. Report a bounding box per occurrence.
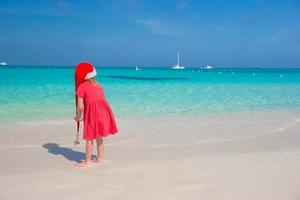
[0,66,300,123]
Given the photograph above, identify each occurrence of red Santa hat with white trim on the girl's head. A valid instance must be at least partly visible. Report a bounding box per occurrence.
[75,62,97,90]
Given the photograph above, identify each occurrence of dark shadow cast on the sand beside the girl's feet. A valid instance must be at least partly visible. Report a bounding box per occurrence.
[43,143,95,162]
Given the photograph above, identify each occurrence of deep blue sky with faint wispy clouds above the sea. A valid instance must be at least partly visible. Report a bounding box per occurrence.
[0,0,300,67]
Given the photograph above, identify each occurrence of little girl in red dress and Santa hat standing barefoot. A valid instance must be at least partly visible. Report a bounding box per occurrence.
[74,63,118,167]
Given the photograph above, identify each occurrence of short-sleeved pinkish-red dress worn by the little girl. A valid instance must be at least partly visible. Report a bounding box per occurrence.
[76,81,118,140]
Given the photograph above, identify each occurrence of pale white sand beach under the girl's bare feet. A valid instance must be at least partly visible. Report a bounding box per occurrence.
[0,110,300,200]
